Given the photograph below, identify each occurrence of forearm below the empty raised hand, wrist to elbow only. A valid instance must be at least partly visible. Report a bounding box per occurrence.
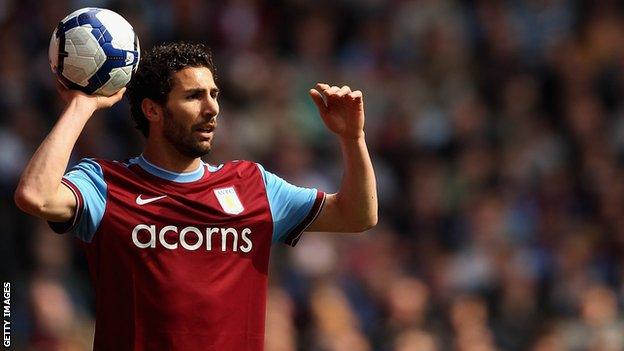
[336,135,377,230]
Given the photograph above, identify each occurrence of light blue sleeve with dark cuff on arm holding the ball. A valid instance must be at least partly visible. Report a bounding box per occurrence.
[48,159,106,242]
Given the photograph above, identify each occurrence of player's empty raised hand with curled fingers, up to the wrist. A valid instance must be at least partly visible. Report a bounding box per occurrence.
[310,83,364,139]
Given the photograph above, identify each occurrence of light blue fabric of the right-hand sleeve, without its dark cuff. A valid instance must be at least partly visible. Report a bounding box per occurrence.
[257,164,317,243]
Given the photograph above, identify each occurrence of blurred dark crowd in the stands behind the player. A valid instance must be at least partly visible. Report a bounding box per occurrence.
[0,0,624,351]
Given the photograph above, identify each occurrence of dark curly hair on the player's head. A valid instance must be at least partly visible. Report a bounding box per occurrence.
[127,42,216,138]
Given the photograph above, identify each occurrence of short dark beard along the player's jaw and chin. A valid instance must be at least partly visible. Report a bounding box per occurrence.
[163,108,212,158]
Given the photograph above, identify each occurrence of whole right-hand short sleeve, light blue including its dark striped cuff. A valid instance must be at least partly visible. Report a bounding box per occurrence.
[258,164,325,246]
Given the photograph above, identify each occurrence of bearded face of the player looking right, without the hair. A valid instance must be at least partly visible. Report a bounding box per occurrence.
[163,67,219,158]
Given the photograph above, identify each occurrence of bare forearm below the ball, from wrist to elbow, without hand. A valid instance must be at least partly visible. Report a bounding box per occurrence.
[16,100,93,206]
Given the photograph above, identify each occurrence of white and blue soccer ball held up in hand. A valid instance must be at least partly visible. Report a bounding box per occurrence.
[48,7,140,96]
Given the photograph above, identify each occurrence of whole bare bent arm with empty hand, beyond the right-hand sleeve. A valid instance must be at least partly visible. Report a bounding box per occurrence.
[306,83,377,232]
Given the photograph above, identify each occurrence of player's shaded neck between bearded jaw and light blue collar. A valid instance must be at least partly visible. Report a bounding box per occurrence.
[143,138,201,173]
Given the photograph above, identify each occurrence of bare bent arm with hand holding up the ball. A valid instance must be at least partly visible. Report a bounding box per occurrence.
[14,83,125,222]
